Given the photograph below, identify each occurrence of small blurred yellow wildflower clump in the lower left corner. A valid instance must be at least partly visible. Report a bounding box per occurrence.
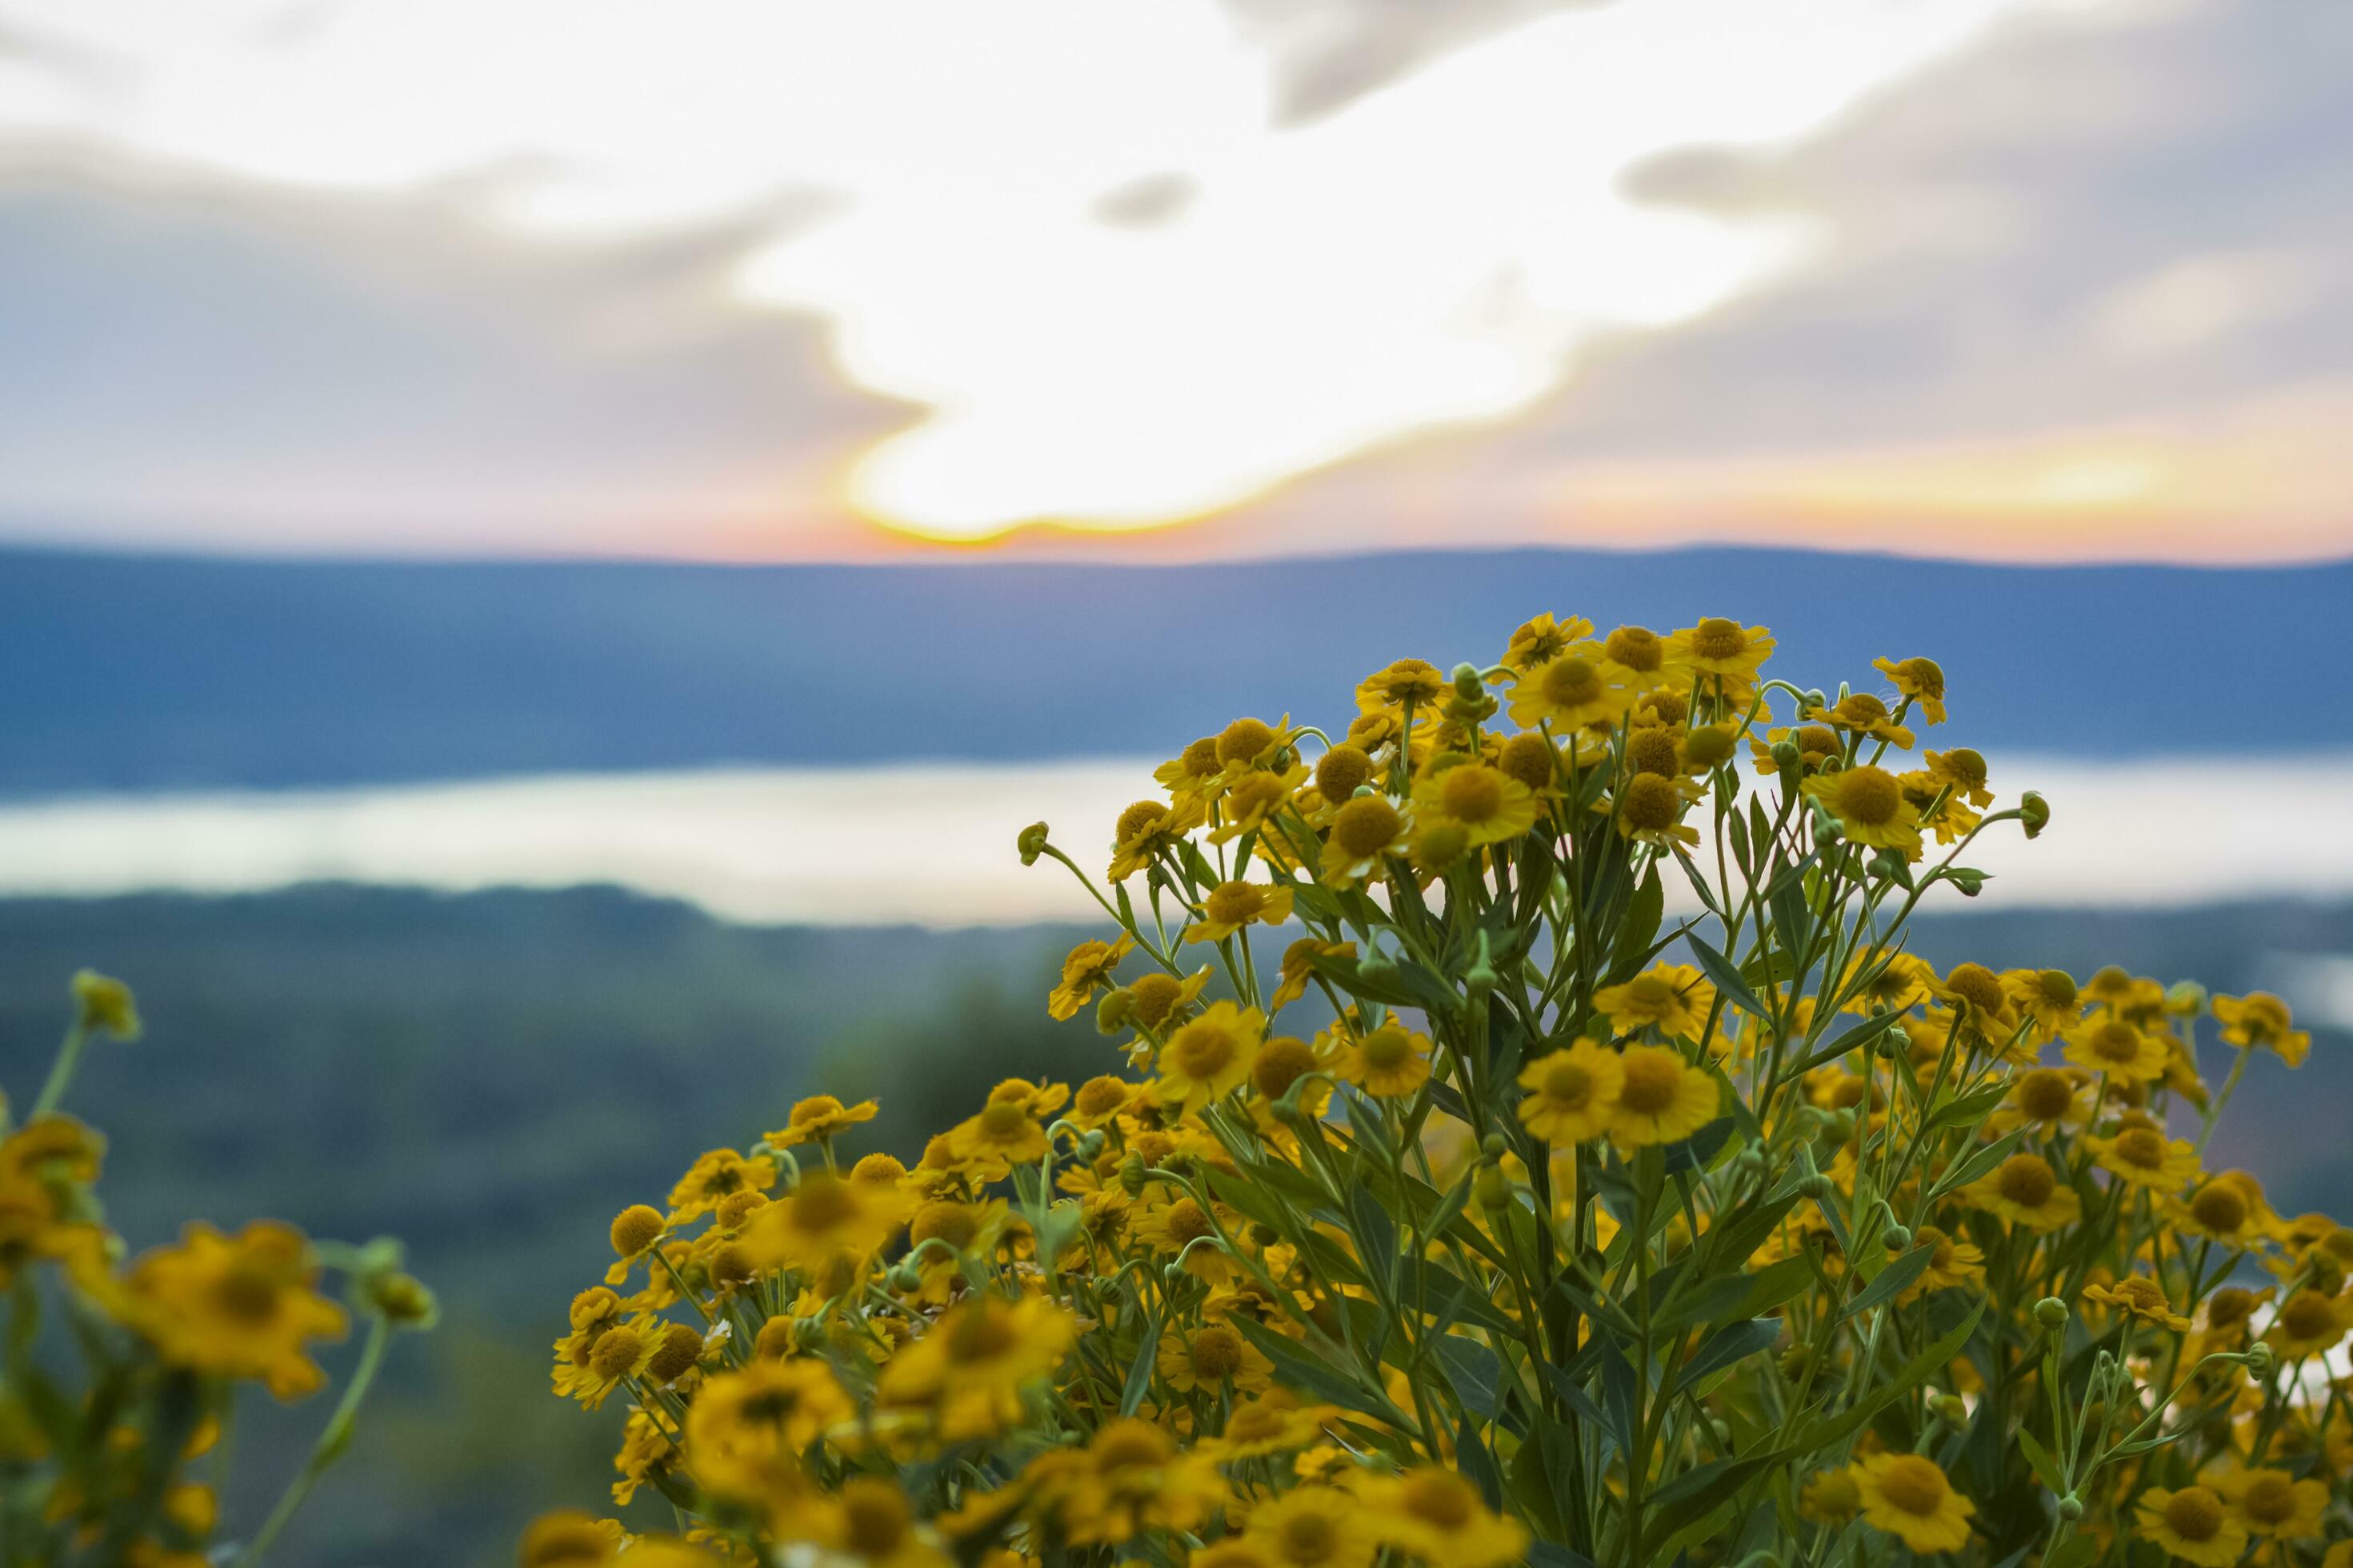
[0,970,435,1568]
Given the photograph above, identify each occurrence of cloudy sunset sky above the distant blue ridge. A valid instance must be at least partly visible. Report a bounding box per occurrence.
[0,0,2353,562]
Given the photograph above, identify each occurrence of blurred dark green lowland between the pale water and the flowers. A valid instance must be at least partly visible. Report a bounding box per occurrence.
[0,887,2353,1568]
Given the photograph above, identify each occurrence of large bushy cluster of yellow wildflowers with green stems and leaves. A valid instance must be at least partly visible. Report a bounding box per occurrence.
[538,614,2353,1568]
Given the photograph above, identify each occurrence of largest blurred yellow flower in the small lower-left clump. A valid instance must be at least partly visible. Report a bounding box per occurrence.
[110,1219,346,1398]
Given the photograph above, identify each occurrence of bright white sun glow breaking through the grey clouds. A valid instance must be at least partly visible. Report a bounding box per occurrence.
[0,0,2061,539]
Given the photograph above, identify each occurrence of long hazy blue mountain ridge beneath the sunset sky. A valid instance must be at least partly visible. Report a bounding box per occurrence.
[0,549,2353,796]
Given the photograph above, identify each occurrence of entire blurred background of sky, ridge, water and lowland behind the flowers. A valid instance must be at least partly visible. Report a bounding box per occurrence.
[0,0,2353,1566]
